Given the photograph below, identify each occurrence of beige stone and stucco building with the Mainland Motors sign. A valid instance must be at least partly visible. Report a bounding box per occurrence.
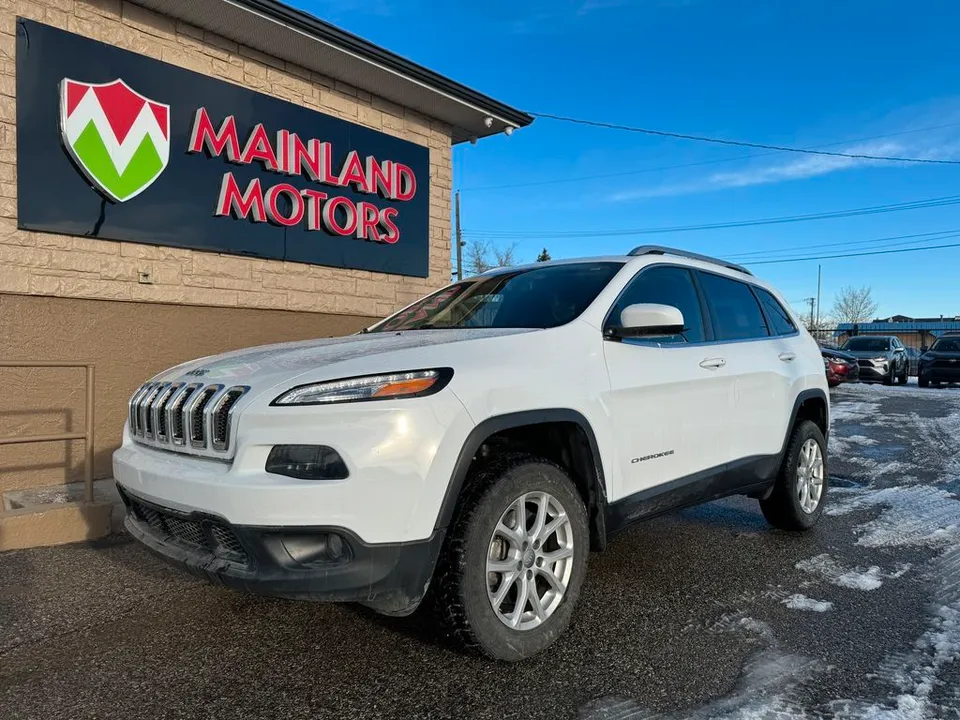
[0,0,532,496]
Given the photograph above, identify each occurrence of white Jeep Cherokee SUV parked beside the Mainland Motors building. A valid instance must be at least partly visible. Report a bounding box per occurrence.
[113,246,829,660]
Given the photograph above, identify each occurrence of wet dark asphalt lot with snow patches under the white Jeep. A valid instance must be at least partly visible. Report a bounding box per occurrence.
[0,385,960,720]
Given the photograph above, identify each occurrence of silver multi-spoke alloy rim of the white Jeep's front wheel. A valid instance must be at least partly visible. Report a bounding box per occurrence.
[486,492,574,630]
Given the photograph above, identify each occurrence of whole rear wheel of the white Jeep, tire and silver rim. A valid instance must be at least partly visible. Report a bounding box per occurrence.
[760,420,827,530]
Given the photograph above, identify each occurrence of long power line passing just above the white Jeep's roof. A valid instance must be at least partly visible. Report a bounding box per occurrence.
[464,195,960,240]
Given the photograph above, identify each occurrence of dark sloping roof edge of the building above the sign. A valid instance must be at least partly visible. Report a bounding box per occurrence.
[230,0,534,128]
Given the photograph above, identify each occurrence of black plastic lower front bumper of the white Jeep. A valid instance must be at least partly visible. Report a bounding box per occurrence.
[119,486,443,615]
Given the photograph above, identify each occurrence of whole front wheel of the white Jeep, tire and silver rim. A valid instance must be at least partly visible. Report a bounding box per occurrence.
[434,456,590,661]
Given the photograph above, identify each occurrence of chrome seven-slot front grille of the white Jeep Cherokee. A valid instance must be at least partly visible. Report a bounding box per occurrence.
[129,383,250,453]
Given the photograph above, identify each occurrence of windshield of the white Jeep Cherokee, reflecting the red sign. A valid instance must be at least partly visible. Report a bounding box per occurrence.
[370,262,623,332]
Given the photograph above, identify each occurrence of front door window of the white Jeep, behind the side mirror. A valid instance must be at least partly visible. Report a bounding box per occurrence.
[607,266,706,343]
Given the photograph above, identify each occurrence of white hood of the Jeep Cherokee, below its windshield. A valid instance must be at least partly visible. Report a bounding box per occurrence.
[152,328,532,389]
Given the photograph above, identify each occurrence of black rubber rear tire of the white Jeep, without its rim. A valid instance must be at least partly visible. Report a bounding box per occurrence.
[760,420,828,531]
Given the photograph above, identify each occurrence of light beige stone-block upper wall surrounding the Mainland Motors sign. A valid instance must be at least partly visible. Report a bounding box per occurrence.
[0,0,452,316]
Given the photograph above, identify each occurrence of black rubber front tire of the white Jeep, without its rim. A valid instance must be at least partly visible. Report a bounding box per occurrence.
[432,455,590,662]
